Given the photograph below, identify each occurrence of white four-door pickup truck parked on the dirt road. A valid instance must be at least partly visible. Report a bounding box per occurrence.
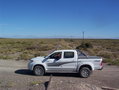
[28,50,103,78]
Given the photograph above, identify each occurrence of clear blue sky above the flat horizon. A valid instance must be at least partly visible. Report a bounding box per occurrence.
[0,0,119,38]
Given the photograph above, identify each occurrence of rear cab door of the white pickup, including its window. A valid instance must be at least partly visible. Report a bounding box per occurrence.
[60,51,77,72]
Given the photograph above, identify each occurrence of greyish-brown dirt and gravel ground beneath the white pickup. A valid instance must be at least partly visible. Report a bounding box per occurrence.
[0,60,119,90]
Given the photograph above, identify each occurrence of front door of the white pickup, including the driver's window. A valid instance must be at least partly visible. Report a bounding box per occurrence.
[46,52,62,72]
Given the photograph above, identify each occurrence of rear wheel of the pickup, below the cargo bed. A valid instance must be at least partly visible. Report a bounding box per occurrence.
[79,67,91,78]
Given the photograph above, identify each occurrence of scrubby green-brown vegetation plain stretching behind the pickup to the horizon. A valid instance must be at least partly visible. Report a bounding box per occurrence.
[0,39,119,65]
